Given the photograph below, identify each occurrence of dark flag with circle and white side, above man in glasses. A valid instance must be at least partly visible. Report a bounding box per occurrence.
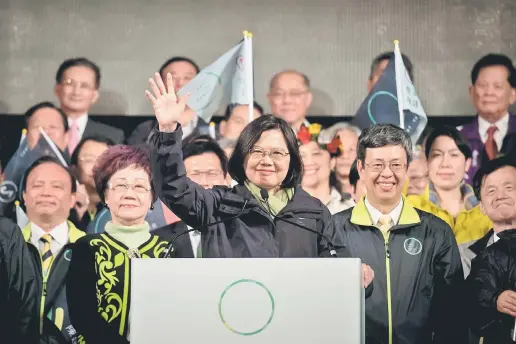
[353,42,428,144]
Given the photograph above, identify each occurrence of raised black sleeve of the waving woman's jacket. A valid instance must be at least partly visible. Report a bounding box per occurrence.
[149,125,227,228]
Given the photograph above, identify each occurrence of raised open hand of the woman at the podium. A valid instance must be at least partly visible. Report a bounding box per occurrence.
[145,73,189,132]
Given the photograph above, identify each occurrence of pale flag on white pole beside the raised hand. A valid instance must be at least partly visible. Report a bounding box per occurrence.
[178,33,253,122]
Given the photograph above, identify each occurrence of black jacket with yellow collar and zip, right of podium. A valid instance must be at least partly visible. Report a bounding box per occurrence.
[334,200,468,344]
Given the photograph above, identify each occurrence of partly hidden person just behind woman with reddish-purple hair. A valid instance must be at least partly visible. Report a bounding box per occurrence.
[71,136,115,231]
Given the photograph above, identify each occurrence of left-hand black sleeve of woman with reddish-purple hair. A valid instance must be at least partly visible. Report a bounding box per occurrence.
[66,239,129,344]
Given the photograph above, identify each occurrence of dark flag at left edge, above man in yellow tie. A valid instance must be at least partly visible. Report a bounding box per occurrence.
[0,128,67,216]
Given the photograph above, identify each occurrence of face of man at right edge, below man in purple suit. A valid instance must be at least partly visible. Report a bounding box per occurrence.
[480,166,516,223]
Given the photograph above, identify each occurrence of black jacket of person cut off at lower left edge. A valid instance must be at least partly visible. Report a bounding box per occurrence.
[0,218,38,344]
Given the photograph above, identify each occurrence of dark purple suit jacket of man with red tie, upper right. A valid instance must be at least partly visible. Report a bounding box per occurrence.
[457,114,516,184]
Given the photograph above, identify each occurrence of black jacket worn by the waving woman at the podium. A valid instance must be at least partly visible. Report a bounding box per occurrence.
[150,126,349,258]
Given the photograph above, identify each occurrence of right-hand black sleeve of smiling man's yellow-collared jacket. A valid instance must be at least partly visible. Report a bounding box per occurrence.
[429,217,469,344]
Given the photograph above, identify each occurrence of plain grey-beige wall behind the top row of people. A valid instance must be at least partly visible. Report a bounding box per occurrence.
[0,0,516,116]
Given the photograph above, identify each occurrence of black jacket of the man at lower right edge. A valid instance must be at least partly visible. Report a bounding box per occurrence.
[466,229,516,344]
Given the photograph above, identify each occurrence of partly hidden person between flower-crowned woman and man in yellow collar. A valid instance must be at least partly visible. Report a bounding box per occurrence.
[321,122,361,194]
